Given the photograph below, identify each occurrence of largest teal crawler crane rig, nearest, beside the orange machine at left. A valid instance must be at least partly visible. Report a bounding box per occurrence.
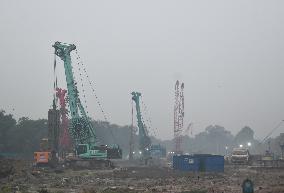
[53,42,121,168]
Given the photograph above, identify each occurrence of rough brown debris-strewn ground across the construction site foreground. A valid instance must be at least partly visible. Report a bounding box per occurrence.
[0,159,284,193]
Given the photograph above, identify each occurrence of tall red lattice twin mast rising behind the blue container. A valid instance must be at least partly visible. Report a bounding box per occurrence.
[174,80,184,154]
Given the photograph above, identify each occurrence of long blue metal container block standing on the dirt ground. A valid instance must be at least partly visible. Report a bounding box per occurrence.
[173,154,224,172]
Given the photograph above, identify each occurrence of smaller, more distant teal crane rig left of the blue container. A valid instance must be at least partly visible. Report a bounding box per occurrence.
[131,92,166,165]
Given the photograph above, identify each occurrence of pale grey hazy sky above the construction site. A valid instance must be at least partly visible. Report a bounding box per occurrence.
[0,0,284,139]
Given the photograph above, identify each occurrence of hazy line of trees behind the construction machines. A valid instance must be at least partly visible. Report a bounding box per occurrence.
[0,110,283,159]
